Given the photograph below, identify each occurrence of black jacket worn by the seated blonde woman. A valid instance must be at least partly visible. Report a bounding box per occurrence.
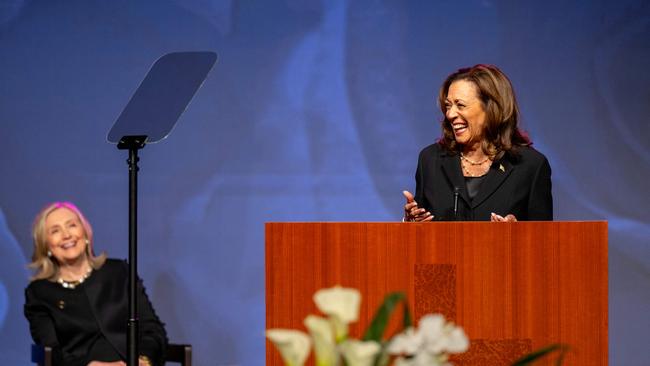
[24,259,167,366]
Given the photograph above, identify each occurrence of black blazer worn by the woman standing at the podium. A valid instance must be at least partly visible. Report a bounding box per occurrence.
[415,143,553,221]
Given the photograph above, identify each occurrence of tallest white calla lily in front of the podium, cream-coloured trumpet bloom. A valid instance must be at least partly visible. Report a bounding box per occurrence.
[314,286,361,342]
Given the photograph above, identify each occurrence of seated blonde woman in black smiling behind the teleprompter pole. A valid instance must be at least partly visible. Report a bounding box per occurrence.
[25,202,167,366]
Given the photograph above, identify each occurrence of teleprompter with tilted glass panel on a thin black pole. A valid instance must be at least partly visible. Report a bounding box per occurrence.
[108,52,217,366]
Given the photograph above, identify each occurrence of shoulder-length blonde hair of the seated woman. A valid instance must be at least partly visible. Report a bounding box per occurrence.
[28,202,106,281]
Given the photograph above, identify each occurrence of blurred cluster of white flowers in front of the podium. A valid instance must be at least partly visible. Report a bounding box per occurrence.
[267,286,469,366]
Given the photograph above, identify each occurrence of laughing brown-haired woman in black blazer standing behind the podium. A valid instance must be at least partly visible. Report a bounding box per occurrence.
[403,65,553,222]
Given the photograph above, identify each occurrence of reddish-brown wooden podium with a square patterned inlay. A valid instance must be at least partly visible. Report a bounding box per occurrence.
[266,222,608,366]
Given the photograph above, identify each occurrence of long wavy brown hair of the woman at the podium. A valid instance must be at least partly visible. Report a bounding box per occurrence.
[438,64,532,159]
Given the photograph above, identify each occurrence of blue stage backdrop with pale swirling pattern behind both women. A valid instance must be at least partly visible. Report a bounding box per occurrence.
[0,0,650,365]
